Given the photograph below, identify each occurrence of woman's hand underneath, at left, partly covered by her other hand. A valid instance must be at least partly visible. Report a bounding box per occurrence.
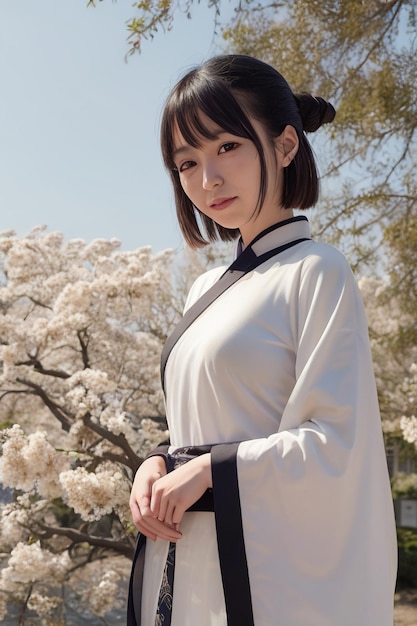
[129,456,181,542]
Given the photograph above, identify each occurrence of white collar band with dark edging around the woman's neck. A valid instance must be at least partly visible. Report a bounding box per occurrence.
[236,215,311,258]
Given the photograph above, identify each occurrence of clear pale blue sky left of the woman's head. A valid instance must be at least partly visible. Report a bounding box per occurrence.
[0,0,237,251]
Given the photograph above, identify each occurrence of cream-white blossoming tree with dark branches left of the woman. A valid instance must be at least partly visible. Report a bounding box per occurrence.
[0,229,208,624]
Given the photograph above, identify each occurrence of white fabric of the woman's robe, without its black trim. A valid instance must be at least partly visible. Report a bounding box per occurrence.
[141,218,396,626]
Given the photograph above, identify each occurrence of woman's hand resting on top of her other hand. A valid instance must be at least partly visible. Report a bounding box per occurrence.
[150,454,212,528]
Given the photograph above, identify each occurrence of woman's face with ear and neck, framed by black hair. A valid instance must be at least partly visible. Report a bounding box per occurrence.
[174,114,298,245]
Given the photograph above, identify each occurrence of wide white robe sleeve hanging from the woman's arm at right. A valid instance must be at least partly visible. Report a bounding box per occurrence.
[212,251,396,626]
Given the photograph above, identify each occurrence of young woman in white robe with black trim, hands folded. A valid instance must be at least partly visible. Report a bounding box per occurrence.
[129,55,396,626]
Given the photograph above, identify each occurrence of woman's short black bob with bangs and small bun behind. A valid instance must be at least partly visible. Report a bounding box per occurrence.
[161,55,335,248]
